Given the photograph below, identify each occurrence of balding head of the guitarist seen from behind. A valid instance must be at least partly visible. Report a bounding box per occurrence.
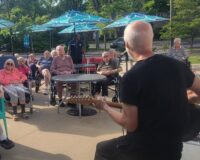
[124,21,153,54]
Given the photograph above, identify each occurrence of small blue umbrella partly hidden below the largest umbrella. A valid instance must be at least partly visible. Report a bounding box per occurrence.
[59,24,100,34]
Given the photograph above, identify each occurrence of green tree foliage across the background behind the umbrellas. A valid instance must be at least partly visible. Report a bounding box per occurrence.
[0,0,200,51]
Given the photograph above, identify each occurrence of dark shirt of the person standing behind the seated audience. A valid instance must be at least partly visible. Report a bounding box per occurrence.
[69,40,83,62]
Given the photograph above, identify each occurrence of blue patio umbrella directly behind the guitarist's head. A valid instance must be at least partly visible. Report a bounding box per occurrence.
[105,12,168,28]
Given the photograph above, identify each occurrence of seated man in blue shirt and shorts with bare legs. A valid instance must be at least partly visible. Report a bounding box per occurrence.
[37,51,53,95]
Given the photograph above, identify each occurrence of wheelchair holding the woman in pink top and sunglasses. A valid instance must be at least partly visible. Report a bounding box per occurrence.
[0,55,33,114]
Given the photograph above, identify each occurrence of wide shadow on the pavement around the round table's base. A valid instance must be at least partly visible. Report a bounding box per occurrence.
[16,94,121,137]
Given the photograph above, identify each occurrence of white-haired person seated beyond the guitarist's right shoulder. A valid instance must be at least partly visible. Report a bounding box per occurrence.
[168,38,188,63]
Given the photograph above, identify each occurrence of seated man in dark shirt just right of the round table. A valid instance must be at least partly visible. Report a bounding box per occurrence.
[95,52,119,96]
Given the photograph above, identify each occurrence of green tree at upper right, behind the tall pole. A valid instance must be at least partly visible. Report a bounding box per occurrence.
[161,0,200,47]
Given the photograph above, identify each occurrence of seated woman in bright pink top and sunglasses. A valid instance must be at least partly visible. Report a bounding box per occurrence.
[0,59,28,121]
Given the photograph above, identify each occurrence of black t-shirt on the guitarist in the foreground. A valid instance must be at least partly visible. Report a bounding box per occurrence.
[120,55,194,146]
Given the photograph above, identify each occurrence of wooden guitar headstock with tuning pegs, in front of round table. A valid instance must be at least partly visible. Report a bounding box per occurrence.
[67,96,95,105]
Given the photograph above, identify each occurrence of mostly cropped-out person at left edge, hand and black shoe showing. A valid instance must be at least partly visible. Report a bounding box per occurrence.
[0,88,15,159]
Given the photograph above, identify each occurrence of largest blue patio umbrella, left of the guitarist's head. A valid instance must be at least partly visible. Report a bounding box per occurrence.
[44,11,111,27]
